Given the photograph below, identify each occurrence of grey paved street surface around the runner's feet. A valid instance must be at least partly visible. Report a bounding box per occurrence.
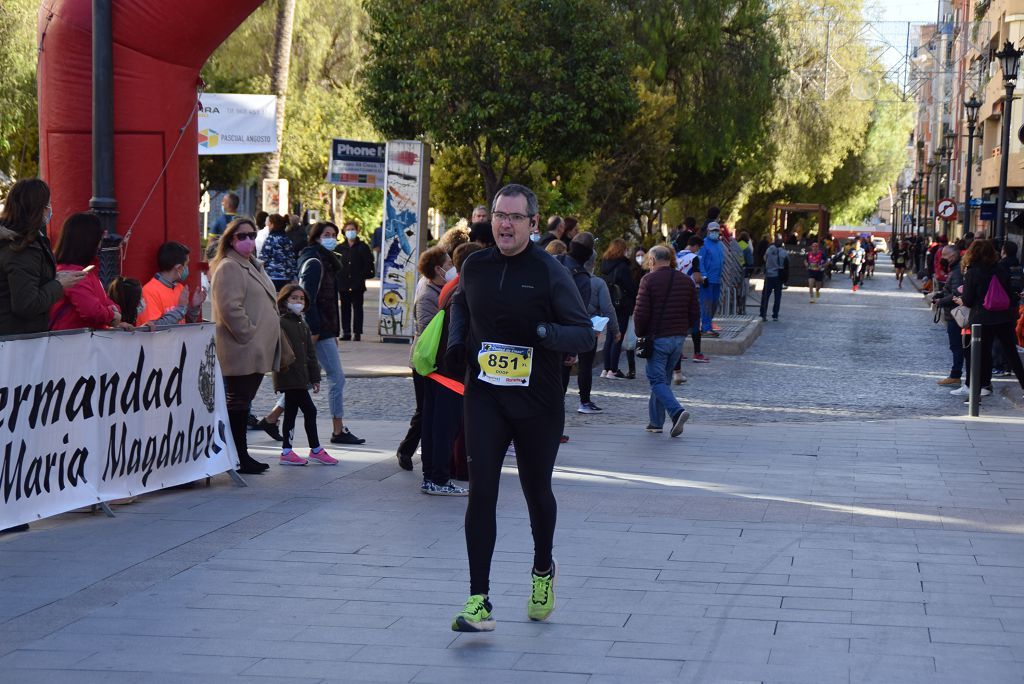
[0,254,1024,684]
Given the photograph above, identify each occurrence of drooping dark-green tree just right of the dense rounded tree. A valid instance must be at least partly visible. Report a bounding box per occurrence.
[622,0,783,205]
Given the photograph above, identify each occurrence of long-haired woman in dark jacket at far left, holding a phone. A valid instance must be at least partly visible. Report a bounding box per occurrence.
[0,178,85,335]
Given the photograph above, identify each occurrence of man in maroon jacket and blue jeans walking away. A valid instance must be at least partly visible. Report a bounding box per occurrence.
[633,245,700,437]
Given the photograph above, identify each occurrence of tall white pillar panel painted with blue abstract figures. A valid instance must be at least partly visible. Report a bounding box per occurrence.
[379,140,430,341]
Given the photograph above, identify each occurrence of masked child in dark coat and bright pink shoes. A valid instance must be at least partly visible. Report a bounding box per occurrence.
[273,284,338,466]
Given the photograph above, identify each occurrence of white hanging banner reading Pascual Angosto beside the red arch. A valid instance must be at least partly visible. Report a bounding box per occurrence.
[198,92,278,155]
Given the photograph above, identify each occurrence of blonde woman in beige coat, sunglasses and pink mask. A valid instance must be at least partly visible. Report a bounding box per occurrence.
[210,218,281,474]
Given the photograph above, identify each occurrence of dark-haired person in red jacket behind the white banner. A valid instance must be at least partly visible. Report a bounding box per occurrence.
[50,213,134,330]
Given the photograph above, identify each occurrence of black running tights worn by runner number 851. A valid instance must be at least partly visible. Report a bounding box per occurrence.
[464,389,565,594]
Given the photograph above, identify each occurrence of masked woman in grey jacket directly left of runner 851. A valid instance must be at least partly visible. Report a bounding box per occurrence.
[399,247,469,497]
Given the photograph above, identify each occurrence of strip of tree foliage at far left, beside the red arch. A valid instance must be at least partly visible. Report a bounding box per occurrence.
[0,0,39,180]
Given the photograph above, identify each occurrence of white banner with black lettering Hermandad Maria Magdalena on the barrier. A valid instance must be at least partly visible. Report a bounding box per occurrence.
[0,324,238,529]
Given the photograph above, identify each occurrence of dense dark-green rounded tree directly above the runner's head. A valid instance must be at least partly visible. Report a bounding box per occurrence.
[359,0,636,202]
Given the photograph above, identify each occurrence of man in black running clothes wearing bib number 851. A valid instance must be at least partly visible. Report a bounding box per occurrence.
[446,184,594,632]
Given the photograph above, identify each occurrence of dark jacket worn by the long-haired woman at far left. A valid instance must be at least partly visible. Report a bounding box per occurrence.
[0,225,63,335]
